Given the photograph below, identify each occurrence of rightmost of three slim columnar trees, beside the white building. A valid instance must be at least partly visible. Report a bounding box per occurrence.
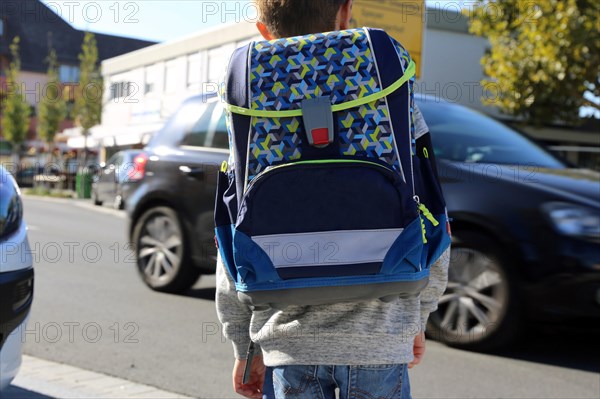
[73,32,103,135]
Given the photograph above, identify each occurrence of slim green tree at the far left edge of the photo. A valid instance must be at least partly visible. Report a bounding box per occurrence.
[2,36,31,158]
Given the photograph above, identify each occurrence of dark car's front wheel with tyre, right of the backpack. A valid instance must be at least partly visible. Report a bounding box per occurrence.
[428,231,520,351]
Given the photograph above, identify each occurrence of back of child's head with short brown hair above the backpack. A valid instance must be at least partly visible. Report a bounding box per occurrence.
[254,0,351,37]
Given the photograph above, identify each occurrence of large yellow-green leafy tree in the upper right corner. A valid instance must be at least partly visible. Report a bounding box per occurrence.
[469,0,600,125]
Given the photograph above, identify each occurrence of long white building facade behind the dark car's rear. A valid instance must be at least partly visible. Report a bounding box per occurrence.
[86,23,257,154]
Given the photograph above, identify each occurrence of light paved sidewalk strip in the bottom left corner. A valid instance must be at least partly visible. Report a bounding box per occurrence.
[0,355,189,399]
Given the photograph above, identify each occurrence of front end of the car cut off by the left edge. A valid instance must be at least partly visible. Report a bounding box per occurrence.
[0,166,33,390]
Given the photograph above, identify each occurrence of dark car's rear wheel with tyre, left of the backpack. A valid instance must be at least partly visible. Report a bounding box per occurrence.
[133,206,200,293]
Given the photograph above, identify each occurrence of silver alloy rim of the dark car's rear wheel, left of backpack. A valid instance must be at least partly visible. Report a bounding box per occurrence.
[138,215,183,282]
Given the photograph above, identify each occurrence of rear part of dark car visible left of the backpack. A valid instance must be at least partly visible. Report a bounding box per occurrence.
[126,96,229,292]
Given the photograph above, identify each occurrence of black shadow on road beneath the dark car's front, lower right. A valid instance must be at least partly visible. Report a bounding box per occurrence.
[496,329,600,373]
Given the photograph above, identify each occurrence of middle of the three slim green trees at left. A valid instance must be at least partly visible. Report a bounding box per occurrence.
[37,49,67,158]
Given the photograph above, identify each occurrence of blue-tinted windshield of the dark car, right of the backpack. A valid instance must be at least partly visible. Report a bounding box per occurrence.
[417,98,565,168]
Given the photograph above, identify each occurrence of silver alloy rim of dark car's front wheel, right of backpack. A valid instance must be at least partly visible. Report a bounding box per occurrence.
[436,247,508,342]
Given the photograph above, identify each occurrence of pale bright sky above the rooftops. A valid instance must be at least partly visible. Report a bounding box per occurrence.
[42,0,464,41]
